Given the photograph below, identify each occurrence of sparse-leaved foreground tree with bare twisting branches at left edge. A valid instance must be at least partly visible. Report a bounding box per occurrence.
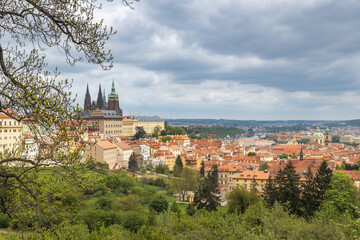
[0,0,136,230]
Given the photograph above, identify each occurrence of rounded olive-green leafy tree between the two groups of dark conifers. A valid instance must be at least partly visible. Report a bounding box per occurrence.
[228,188,259,215]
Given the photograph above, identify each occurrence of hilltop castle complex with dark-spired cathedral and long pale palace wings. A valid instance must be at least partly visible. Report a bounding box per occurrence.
[82,80,165,137]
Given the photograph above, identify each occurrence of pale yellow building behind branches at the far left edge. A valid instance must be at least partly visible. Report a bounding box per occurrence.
[0,113,22,153]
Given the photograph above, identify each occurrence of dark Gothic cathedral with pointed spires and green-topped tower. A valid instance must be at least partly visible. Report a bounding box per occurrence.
[84,80,122,116]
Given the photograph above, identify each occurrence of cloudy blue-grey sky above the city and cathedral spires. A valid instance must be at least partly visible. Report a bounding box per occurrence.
[60,0,360,120]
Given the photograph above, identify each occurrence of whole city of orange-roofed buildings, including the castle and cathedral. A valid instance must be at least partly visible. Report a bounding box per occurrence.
[0,81,360,199]
